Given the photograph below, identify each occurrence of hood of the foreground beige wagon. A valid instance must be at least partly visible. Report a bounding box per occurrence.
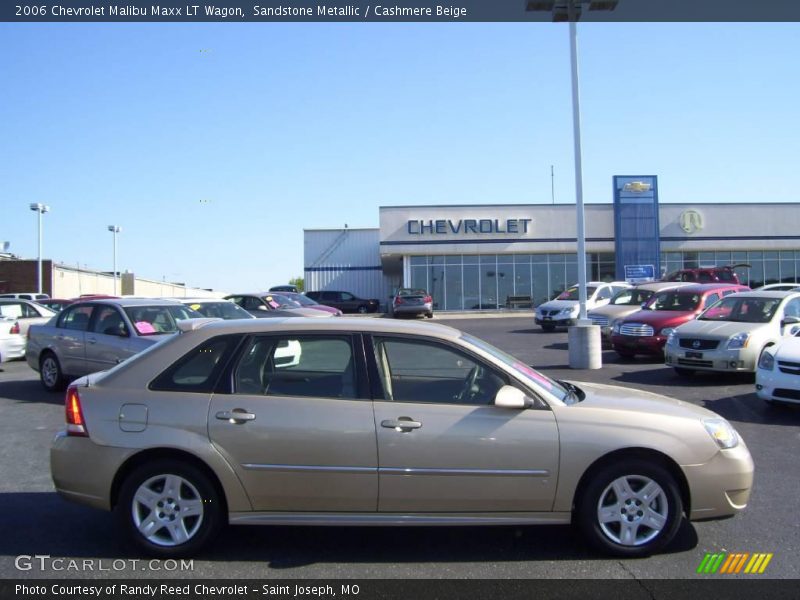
[572,381,719,418]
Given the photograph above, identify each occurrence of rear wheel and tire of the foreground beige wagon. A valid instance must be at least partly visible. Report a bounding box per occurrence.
[114,459,225,558]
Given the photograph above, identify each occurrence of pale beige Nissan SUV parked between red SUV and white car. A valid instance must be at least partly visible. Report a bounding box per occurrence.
[665,292,800,375]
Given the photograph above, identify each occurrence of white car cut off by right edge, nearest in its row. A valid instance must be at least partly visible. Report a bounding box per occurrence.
[756,327,800,404]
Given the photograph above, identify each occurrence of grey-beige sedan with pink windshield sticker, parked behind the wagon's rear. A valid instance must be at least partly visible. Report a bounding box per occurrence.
[25,298,202,391]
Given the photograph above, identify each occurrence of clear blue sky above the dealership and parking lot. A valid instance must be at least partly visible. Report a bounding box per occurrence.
[0,23,800,291]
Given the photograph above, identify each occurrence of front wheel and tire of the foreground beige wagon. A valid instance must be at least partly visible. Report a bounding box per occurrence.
[576,458,683,558]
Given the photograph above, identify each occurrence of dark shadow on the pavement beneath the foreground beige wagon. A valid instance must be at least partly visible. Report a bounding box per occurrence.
[0,492,698,569]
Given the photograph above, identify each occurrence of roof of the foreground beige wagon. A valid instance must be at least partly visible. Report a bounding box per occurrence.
[179,317,462,339]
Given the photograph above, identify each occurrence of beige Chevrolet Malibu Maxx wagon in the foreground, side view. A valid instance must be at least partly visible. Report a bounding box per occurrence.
[51,318,753,557]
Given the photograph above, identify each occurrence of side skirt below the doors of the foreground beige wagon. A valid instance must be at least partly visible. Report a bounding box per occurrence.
[229,512,572,527]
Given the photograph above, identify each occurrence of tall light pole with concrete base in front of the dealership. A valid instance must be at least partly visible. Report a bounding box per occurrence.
[526,0,618,369]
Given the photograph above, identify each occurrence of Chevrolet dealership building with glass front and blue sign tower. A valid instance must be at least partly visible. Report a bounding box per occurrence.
[304,176,800,310]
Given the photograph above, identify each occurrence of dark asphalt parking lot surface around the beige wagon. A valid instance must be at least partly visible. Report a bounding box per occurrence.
[0,316,800,580]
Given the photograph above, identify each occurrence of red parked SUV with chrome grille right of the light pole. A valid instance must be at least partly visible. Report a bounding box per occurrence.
[611,283,750,358]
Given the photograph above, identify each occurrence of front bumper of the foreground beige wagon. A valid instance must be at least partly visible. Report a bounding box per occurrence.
[681,438,753,521]
